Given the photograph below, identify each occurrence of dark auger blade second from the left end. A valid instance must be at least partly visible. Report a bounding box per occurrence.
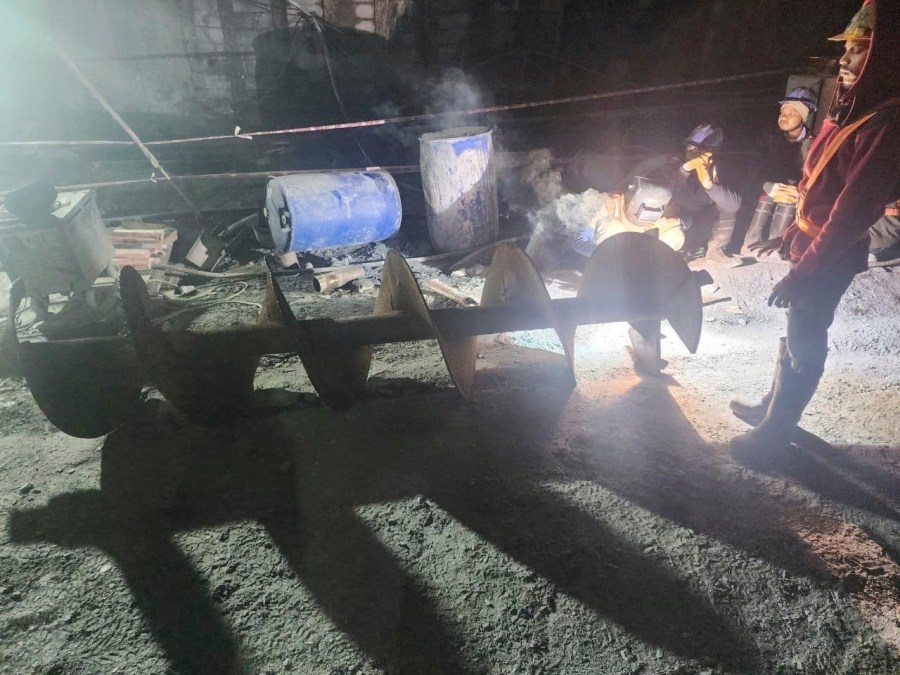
[119,267,259,426]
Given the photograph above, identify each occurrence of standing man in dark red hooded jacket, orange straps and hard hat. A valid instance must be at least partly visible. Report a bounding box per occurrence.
[731,0,900,452]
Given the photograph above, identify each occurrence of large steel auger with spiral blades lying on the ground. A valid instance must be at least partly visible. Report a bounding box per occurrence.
[9,233,702,438]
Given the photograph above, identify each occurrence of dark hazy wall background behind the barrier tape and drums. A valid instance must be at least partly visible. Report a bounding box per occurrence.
[0,0,858,205]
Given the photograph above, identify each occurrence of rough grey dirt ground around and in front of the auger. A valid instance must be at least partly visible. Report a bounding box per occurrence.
[0,255,900,675]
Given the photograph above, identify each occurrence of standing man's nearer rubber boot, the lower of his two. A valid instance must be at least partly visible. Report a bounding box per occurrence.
[731,354,820,454]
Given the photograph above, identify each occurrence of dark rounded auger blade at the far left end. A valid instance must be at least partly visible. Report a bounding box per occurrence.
[7,280,143,438]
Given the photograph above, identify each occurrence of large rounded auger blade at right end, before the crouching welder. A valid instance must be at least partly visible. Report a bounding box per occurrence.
[578,232,703,354]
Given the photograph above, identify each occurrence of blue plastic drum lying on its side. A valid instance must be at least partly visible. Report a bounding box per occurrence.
[266,170,403,253]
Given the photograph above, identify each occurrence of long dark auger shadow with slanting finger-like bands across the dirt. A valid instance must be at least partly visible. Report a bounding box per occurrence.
[10,349,891,673]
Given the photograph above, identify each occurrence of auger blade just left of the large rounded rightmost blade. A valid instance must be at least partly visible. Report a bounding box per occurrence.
[481,243,575,387]
